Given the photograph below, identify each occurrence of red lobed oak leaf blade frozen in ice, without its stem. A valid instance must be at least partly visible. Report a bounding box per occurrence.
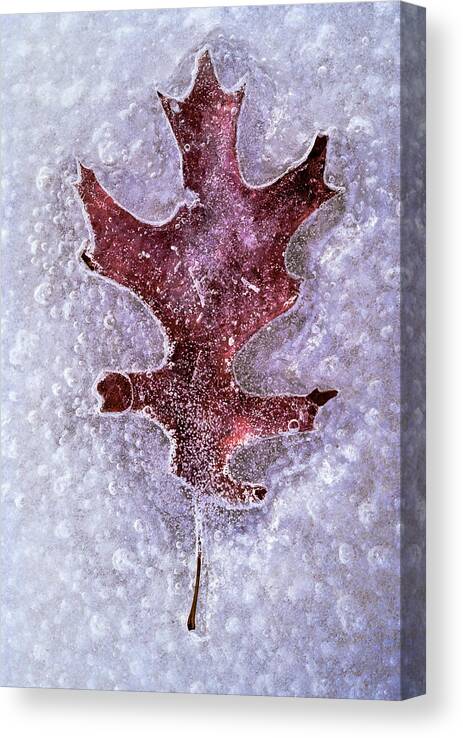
[77,52,337,505]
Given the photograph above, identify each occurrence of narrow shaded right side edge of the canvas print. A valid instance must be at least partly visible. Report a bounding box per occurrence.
[400,3,426,700]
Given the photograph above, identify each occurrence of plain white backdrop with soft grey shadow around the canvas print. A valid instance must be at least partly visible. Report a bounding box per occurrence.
[0,0,463,738]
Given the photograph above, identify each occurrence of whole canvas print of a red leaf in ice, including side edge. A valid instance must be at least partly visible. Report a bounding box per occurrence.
[0,2,425,700]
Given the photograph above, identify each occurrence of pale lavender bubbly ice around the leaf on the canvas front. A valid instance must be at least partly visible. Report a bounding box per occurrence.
[1,3,414,698]
